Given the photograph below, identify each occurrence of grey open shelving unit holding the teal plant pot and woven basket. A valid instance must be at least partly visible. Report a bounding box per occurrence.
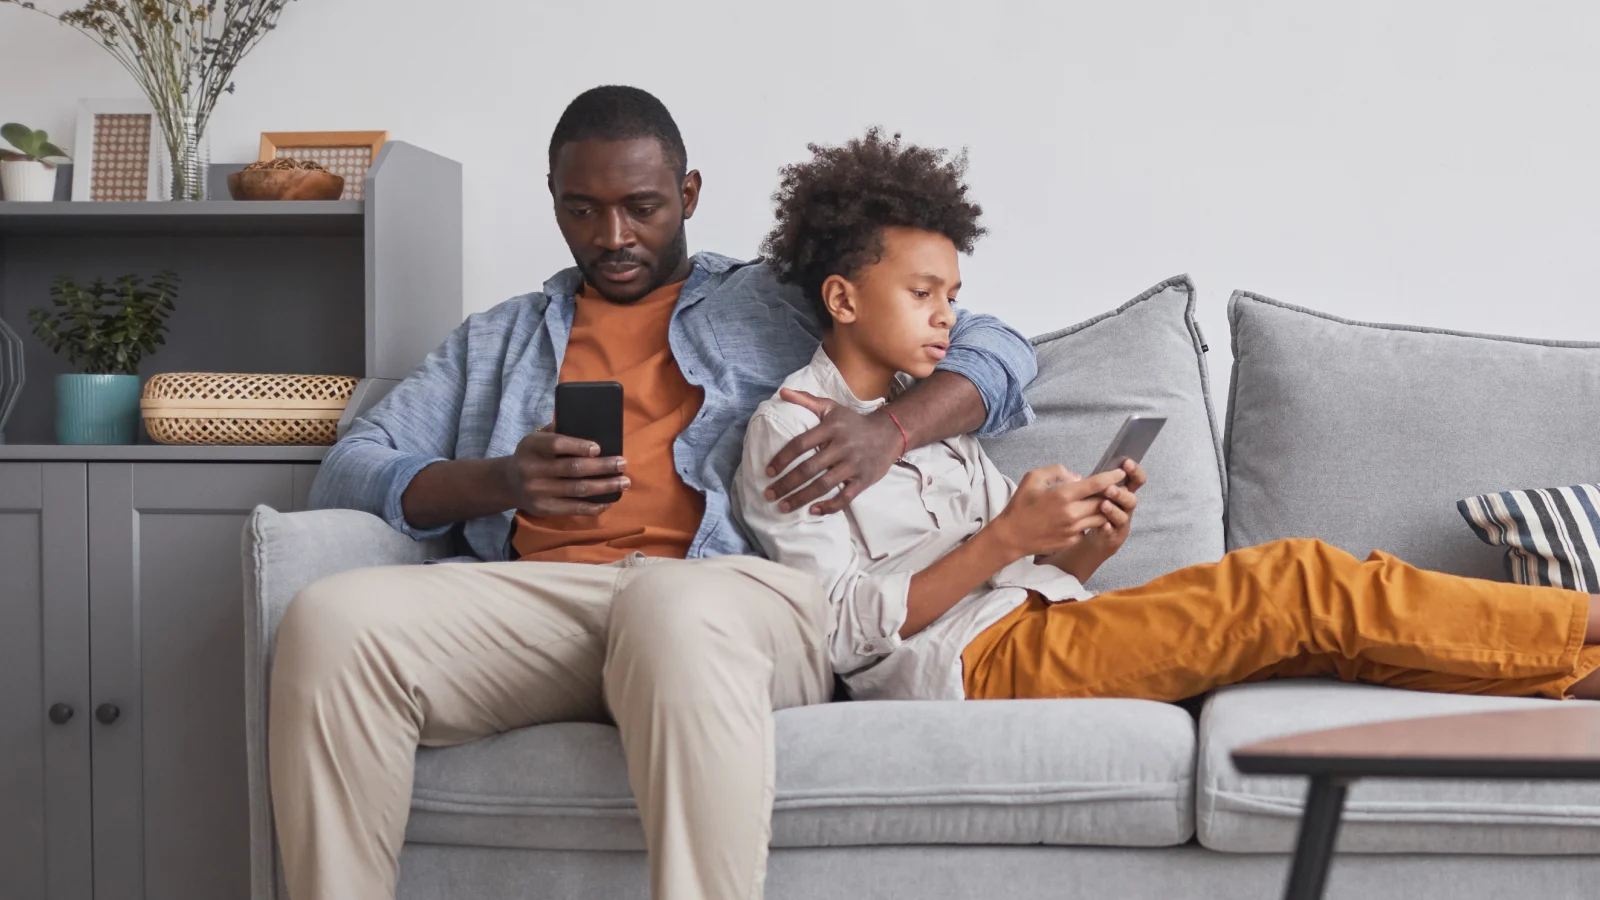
[0,141,461,448]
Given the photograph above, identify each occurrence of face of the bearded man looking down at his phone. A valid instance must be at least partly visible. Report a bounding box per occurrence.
[550,138,701,303]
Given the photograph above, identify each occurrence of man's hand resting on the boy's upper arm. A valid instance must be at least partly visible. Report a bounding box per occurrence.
[766,388,902,516]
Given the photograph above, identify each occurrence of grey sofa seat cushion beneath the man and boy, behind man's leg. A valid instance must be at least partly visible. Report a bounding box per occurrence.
[406,700,1195,850]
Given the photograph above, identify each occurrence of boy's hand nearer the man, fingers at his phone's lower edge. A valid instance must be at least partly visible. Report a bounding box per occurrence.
[990,466,1126,559]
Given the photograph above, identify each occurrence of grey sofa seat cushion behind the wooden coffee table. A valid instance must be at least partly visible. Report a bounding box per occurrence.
[1195,681,1600,854]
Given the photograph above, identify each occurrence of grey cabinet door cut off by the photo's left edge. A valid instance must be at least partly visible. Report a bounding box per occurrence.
[0,463,94,900]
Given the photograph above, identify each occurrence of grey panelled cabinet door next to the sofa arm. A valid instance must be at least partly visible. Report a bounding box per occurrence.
[90,463,294,900]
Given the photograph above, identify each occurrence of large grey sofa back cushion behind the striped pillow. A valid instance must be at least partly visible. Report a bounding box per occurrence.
[1226,291,1600,578]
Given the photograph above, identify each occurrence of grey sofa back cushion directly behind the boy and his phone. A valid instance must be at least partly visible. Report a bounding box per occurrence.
[984,275,1224,591]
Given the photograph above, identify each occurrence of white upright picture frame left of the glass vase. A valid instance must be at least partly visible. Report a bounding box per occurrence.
[72,98,165,202]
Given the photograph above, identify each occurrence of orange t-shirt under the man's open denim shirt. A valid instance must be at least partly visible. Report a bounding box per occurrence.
[512,282,706,562]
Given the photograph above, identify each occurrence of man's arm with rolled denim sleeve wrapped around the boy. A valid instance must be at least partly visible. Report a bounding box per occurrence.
[766,312,1038,516]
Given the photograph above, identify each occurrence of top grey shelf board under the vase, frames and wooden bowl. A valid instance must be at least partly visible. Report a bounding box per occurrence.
[0,200,365,235]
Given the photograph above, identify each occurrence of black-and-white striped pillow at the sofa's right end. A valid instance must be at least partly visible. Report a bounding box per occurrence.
[1456,484,1600,594]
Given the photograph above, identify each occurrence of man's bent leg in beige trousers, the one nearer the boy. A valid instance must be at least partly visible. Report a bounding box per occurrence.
[605,557,834,900]
